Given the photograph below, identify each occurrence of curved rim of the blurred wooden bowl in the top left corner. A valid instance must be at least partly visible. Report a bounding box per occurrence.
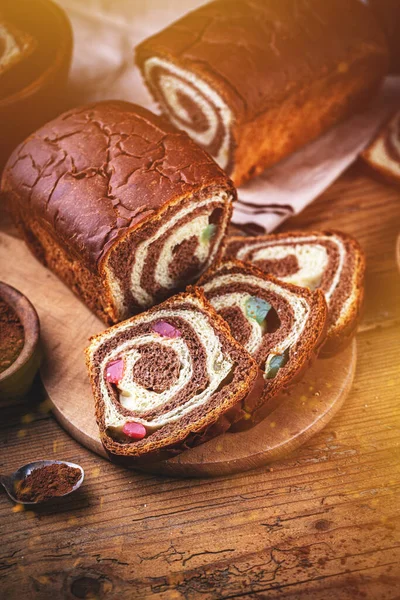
[0,0,73,109]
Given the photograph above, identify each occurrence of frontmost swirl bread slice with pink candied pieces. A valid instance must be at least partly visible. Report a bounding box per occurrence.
[86,290,263,465]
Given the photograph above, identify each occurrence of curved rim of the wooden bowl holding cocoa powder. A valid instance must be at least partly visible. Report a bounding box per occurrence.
[0,281,40,383]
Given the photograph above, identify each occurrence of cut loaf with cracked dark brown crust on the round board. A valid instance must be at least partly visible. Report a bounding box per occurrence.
[2,102,236,323]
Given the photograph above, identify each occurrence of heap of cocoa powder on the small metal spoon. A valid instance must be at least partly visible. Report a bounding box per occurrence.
[14,463,81,502]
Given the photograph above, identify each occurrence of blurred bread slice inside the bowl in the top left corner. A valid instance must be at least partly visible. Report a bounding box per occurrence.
[0,18,36,81]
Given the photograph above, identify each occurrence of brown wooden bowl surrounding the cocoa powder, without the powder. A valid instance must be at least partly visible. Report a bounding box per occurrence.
[0,281,42,405]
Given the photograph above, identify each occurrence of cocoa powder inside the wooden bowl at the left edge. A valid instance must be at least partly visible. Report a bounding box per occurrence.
[0,296,25,373]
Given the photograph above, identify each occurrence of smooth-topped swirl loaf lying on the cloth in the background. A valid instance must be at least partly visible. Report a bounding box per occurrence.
[136,0,388,185]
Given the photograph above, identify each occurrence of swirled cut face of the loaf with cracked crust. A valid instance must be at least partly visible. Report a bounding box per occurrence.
[107,191,229,315]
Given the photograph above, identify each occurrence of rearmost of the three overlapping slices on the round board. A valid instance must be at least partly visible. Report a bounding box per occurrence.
[225,231,365,356]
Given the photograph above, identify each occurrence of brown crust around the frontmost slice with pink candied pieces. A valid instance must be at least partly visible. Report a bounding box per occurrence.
[85,287,263,466]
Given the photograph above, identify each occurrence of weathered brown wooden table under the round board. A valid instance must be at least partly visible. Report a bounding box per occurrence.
[0,164,400,600]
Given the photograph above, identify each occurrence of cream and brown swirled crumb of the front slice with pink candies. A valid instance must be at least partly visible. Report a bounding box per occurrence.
[95,305,233,430]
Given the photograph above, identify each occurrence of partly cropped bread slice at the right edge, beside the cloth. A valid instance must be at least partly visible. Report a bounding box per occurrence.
[361,110,400,184]
